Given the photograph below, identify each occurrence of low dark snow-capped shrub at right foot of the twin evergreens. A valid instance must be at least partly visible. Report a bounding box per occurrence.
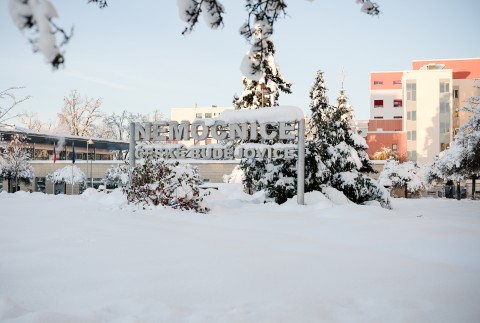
[331,172,392,209]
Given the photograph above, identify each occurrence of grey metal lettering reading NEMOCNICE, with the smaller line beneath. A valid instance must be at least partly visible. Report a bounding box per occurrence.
[134,120,297,160]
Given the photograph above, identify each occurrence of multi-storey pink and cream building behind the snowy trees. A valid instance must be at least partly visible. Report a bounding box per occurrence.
[367,58,480,163]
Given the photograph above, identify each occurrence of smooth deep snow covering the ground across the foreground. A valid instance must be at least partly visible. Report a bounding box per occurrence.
[0,184,480,323]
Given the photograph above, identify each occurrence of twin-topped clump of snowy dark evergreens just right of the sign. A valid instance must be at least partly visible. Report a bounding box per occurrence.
[305,71,390,208]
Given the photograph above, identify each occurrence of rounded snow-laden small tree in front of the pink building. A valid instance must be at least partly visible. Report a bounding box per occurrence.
[378,160,426,197]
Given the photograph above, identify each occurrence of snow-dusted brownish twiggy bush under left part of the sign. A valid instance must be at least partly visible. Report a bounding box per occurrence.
[123,156,208,213]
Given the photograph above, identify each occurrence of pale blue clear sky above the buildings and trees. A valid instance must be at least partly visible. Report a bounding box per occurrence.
[0,0,480,125]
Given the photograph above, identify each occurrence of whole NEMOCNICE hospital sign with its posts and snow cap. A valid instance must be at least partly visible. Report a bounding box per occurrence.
[129,106,305,204]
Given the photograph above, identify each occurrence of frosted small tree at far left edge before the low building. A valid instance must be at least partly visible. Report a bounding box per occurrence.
[0,134,35,189]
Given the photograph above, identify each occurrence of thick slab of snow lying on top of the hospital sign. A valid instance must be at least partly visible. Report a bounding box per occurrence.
[216,105,304,124]
